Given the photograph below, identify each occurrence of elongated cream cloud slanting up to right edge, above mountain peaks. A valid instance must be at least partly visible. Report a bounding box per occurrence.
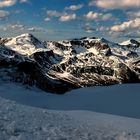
[110,18,140,32]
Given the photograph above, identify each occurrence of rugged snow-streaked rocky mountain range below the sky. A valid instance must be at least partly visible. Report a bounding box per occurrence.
[0,34,140,93]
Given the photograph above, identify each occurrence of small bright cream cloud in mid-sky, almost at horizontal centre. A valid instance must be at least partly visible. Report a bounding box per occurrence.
[59,14,76,22]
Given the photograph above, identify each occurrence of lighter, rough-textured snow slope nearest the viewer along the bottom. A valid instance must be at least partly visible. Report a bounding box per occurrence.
[0,93,140,140]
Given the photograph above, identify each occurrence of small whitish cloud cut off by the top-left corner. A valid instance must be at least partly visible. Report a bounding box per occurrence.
[0,0,17,8]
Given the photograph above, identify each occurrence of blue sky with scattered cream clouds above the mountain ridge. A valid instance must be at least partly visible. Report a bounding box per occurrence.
[0,0,140,42]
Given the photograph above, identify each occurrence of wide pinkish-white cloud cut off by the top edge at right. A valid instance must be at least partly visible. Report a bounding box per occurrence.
[89,0,140,9]
